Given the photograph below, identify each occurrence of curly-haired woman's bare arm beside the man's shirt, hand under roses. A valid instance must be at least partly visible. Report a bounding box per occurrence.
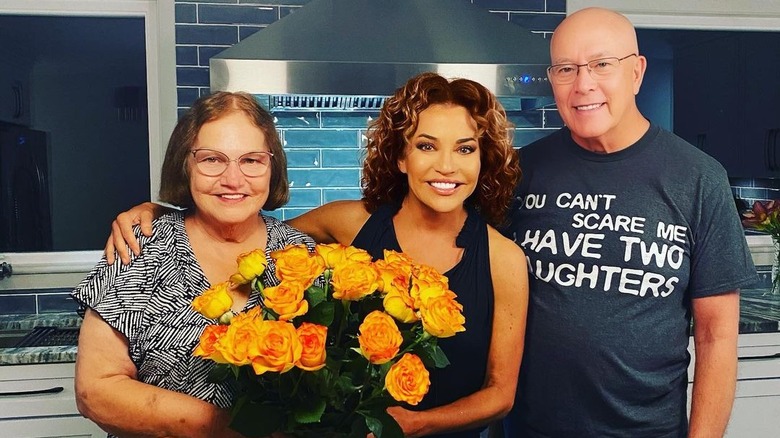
[388,227,528,437]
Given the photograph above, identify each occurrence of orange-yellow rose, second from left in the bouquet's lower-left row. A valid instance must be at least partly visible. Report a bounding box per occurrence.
[214,313,263,365]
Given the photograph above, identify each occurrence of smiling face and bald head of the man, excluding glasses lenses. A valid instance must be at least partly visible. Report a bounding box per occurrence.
[550,8,647,152]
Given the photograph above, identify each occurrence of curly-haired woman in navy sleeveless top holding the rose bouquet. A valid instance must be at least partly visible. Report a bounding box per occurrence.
[107,73,528,438]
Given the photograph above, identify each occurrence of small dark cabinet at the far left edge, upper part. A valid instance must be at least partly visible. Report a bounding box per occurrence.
[0,49,32,126]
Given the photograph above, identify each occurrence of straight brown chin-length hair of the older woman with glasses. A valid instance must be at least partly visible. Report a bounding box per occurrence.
[160,91,290,210]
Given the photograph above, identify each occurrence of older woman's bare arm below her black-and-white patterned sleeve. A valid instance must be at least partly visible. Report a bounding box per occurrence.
[75,310,240,437]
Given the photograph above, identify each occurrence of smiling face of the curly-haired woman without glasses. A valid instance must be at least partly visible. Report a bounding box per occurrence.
[398,104,480,217]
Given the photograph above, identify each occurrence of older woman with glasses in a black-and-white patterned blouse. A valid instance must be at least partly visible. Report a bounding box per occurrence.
[72,93,313,437]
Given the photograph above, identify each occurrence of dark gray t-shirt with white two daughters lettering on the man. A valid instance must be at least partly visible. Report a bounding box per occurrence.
[506,126,757,437]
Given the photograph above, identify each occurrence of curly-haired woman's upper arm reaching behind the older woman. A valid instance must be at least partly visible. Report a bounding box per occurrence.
[286,200,371,245]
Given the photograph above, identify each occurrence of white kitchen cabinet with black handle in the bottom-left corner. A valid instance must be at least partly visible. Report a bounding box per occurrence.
[0,363,106,438]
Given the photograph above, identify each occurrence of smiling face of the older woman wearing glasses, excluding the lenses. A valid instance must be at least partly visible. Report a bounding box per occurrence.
[187,111,274,226]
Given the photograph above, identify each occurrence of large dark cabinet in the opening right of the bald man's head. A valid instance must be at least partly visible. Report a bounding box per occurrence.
[674,32,780,177]
